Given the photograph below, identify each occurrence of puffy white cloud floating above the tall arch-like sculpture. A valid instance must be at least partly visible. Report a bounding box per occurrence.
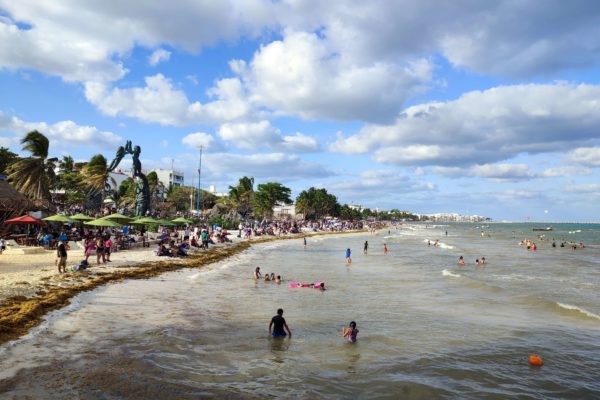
[85,74,248,126]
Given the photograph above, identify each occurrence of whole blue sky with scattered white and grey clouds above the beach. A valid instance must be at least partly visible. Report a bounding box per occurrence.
[0,0,600,222]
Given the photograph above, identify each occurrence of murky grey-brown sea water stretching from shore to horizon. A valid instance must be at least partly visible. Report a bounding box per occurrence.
[0,224,600,399]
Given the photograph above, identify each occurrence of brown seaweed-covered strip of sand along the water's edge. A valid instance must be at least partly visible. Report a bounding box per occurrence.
[0,230,367,345]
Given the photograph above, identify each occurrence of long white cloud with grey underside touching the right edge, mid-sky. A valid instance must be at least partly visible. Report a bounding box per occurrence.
[330,83,600,166]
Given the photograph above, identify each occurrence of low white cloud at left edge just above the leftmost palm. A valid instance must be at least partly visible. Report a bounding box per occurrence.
[0,111,123,149]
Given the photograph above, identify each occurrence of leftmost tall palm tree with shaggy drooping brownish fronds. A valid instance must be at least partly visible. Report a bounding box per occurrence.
[8,131,57,200]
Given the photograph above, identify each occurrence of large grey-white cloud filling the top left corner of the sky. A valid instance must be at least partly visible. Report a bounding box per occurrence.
[0,0,273,82]
